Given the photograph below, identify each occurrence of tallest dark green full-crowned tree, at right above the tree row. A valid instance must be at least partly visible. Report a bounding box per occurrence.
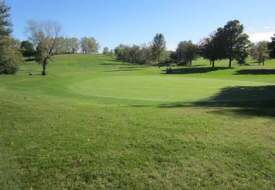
[220,20,250,68]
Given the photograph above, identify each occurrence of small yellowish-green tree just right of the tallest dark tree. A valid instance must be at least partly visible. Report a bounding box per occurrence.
[250,41,269,65]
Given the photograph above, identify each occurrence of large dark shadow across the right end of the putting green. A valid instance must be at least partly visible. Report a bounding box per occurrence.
[158,86,275,117]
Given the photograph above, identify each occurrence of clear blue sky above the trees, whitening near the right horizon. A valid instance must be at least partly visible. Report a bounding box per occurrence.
[6,0,275,50]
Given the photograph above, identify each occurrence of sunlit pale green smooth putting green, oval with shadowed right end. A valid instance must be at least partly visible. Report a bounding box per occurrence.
[69,76,267,102]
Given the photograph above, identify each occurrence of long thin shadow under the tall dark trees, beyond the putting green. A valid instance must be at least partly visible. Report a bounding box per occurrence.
[166,67,232,74]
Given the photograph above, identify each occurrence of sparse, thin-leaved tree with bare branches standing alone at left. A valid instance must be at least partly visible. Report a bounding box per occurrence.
[27,20,61,75]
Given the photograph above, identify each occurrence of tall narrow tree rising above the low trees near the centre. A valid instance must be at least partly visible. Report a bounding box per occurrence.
[152,34,166,63]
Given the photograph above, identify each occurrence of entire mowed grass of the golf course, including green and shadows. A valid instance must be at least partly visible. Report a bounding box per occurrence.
[0,55,275,189]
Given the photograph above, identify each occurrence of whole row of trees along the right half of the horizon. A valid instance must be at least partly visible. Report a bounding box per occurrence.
[114,20,275,68]
